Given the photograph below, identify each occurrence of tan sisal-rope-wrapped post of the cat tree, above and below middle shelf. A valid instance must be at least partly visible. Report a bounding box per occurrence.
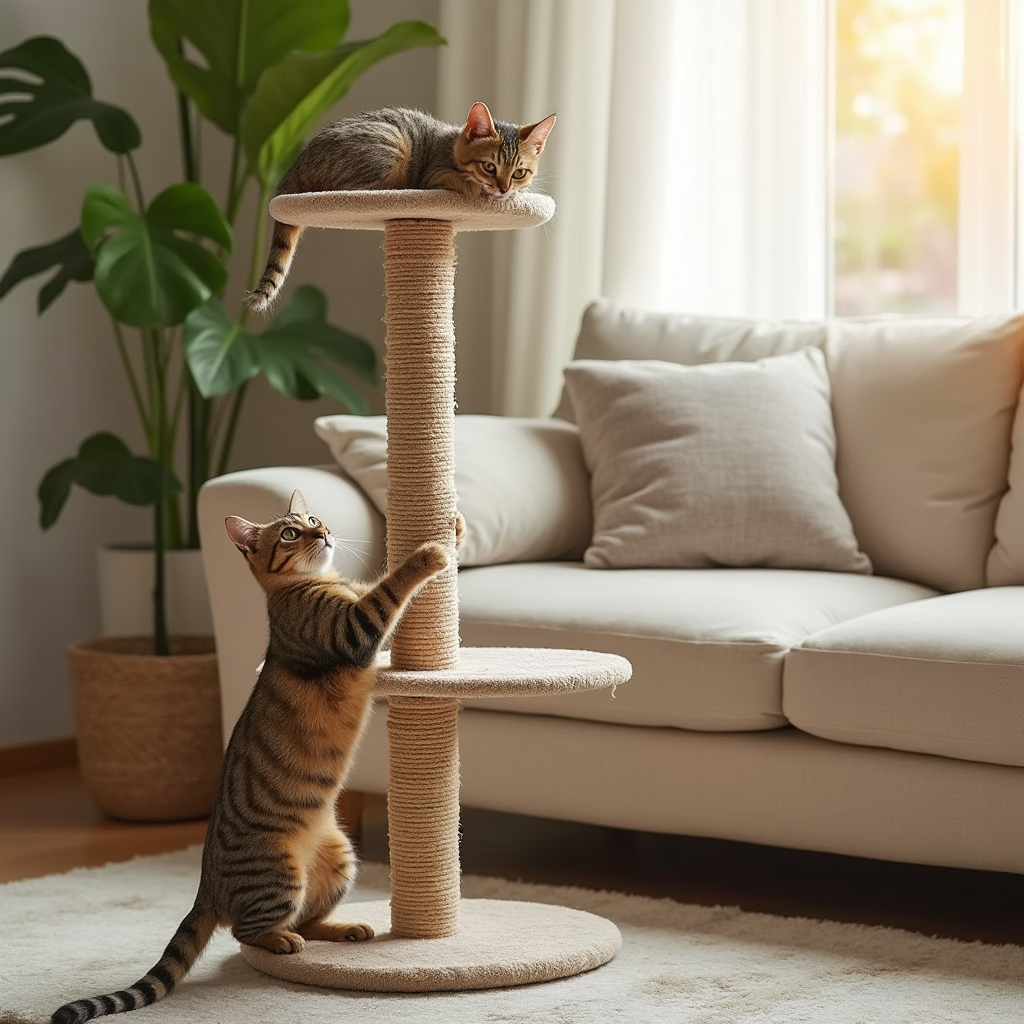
[383,220,461,938]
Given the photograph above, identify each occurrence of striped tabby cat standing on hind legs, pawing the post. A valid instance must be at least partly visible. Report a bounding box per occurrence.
[51,490,465,1024]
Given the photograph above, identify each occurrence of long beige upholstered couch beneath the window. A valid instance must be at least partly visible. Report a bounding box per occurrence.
[195,302,1024,871]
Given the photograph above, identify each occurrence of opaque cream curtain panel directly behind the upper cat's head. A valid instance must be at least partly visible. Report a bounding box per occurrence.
[439,0,615,416]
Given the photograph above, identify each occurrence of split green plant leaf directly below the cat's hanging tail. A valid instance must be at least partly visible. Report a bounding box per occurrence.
[183,285,377,413]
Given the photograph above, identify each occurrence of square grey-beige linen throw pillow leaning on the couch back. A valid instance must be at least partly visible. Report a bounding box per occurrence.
[565,348,871,572]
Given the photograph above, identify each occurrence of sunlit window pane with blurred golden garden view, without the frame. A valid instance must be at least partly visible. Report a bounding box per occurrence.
[833,0,964,315]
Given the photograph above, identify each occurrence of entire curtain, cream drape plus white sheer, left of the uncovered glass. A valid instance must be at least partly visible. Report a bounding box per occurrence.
[440,0,828,416]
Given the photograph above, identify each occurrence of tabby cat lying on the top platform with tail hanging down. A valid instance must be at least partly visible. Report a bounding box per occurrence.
[246,102,555,310]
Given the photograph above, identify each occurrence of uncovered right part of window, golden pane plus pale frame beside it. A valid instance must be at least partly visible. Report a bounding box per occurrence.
[830,0,1024,315]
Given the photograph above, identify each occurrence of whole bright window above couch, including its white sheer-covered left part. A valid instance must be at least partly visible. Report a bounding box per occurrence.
[598,0,1024,318]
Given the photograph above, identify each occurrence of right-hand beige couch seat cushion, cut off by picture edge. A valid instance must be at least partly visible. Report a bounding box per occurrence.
[783,587,1024,765]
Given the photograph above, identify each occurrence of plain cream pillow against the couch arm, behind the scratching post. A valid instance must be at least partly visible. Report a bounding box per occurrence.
[314,416,592,565]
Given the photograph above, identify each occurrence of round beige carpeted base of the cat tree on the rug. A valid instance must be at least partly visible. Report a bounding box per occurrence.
[242,899,623,992]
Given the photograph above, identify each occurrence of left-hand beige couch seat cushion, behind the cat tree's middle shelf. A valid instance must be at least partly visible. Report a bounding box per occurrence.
[459,562,935,731]
